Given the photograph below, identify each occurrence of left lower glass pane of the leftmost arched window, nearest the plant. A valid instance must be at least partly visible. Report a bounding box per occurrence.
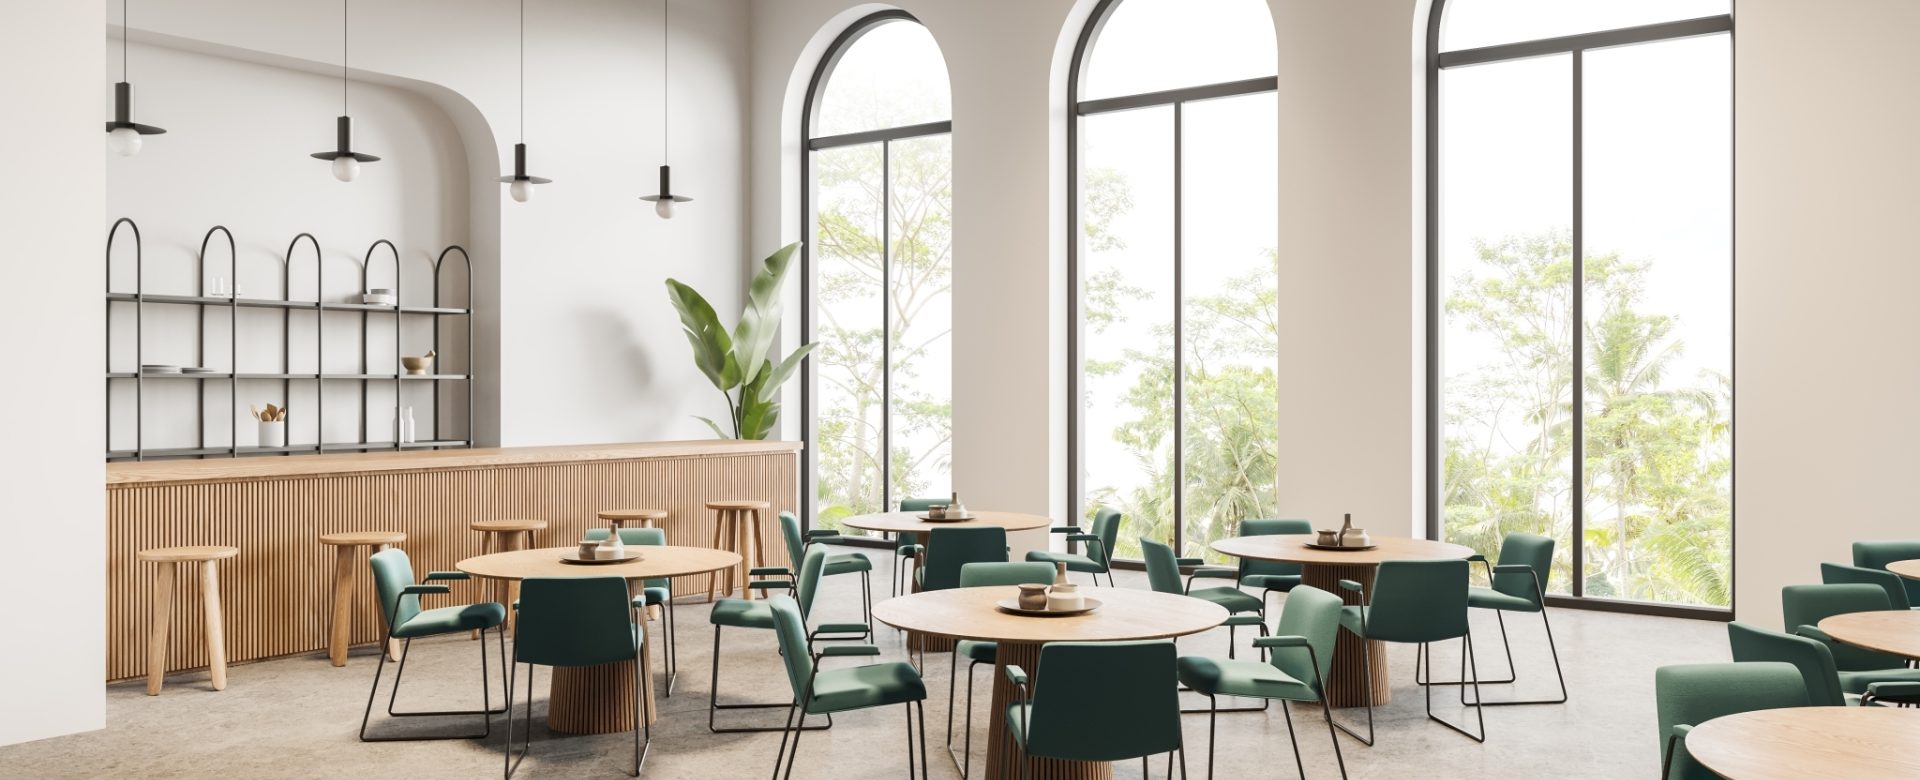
[810,144,887,528]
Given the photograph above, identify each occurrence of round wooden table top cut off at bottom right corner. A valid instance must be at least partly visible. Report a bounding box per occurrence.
[1686,707,1920,780]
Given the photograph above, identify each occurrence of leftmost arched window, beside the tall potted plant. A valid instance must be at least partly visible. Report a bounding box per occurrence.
[801,12,952,528]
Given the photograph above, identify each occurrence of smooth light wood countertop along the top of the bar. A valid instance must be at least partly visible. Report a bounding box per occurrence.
[108,440,801,490]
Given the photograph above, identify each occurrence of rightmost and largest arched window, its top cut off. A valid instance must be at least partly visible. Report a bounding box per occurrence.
[1427,0,1734,611]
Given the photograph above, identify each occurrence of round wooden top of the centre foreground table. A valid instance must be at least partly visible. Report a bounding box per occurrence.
[874,586,1227,644]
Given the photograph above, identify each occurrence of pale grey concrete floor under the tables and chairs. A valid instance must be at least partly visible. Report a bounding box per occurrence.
[0,553,1728,780]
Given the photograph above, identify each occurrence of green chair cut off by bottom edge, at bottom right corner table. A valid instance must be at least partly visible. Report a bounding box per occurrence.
[1653,661,1807,780]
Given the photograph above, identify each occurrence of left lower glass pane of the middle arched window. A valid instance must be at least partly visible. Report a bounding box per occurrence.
[1079,106,1179,559]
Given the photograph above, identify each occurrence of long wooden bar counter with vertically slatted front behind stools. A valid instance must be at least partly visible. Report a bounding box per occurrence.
[106,440,801,680]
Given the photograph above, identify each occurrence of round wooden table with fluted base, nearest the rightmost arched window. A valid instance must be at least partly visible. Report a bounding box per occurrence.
[1213,534,1475,707]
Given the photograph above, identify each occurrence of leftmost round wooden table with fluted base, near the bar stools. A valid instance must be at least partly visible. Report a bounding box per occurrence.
[455,546,739,734]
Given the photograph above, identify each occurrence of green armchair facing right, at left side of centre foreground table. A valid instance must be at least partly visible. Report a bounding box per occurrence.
[768,596,927,778]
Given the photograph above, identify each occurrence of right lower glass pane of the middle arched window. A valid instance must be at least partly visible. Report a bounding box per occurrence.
[1181,92,1281,561]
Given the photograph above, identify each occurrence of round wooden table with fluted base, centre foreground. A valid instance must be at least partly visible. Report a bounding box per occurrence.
[874,586,1227,778]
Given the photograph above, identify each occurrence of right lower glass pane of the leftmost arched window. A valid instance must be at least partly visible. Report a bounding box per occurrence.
[887,134,952,500]
